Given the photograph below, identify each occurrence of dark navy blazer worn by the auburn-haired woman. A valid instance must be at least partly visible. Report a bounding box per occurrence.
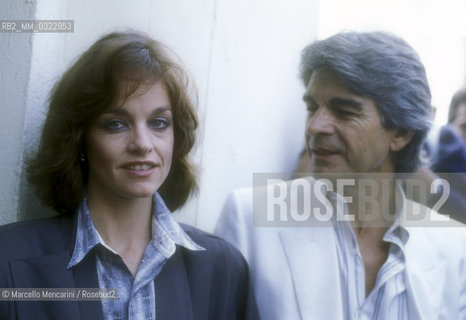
[0,216,258,320]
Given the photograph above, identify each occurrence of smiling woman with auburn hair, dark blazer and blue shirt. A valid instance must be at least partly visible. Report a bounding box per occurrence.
[0,32,256,319]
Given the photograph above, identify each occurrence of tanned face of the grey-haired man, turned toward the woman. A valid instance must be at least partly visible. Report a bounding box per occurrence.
[303,70,395,173]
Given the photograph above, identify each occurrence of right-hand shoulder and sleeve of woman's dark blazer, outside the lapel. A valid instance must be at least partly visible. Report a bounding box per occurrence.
[173,224,259,319]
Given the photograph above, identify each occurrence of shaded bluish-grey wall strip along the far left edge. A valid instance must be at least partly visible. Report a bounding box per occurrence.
[0,0,35,224]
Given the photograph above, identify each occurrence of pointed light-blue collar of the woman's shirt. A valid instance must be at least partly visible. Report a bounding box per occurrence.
[67,193,205,269]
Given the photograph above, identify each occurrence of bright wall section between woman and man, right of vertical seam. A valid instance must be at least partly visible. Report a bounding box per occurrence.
[188,0,317,230]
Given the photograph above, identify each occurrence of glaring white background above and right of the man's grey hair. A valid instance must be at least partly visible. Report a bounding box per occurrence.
[318,0,466,125]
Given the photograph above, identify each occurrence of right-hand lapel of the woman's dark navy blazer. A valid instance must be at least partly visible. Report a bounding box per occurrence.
[155,248,194,320]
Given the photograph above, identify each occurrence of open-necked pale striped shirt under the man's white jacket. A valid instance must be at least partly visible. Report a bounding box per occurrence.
[329,190,409,320]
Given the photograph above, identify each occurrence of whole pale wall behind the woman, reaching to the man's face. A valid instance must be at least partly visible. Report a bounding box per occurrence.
[0,0,317,230]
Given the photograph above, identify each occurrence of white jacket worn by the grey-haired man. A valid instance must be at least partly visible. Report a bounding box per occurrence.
[216,178,466,320]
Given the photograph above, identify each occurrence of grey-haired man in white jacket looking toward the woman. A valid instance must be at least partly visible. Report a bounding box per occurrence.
[217,32,466,320]
